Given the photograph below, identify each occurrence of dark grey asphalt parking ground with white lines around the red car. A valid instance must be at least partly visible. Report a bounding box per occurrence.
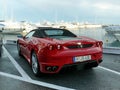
[0,44,120,90]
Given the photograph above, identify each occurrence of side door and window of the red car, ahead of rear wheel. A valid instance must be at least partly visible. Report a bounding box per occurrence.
[22,31,35,58]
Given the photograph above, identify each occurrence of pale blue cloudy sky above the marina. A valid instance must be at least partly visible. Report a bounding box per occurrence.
[0,0,120,24]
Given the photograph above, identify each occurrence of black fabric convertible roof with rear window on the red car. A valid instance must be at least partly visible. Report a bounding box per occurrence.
[33,27,77,37]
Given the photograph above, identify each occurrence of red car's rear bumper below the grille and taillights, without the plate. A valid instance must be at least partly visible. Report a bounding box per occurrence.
[39,48,102,73]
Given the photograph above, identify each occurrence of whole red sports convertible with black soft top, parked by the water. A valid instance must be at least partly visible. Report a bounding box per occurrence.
[17,28,103,75]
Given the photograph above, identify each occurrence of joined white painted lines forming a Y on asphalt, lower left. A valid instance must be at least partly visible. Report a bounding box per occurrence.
[0,46,75,90]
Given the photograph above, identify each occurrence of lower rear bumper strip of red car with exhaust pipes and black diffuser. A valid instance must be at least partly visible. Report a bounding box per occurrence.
[40,56,102,73]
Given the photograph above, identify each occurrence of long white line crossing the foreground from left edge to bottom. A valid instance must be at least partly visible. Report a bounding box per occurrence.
[0,72,75,90]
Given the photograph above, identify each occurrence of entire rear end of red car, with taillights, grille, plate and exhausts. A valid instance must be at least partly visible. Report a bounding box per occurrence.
[40,41,103,73]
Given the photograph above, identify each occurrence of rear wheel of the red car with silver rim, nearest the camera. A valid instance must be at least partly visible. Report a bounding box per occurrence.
[31,52,41,76]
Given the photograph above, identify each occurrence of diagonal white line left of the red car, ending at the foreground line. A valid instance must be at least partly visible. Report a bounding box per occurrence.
[3,46,31,79]
